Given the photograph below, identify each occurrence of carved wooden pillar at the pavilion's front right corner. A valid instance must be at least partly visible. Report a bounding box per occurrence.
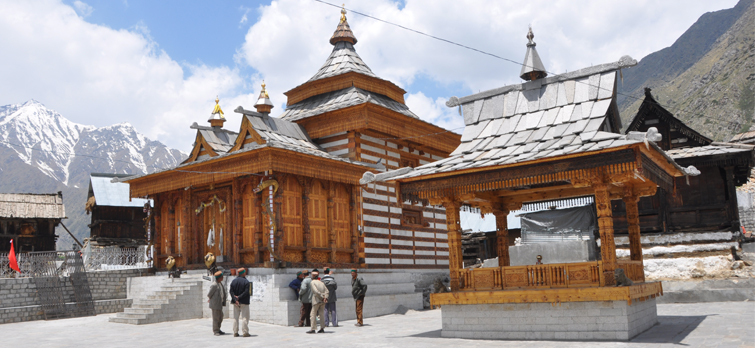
[593,184,616,286]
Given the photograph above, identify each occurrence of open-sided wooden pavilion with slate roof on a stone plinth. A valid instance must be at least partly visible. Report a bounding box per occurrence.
[365,27,697,338]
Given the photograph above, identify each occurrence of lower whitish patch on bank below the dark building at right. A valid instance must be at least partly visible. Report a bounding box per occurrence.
[644,256,731,280]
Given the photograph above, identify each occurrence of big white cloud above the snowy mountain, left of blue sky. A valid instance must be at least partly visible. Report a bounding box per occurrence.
[0,0,255,151]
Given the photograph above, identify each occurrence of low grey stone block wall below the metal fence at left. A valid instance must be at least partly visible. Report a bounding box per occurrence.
[0,269,147,324]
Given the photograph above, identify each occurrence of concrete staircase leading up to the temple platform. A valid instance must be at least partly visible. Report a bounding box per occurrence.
[109,277,203,325]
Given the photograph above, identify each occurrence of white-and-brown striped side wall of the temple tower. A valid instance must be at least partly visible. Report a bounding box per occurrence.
[317,132,448,269]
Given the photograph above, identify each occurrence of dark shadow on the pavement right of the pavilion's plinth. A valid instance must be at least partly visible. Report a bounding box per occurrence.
[630,314,715,346]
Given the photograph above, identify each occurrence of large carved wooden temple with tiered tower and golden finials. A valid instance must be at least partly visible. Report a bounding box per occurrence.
[124,7,460,270]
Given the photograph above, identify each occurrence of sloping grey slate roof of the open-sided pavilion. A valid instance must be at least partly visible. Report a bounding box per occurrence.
[391,57,660,180]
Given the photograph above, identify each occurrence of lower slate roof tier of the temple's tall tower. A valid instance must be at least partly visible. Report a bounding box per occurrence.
[280,87,419,121]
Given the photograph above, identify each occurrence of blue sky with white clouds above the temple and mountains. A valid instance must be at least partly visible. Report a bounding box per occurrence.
[0,0,736,151]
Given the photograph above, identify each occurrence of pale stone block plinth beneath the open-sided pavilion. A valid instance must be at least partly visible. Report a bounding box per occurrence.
[441,299,658,341]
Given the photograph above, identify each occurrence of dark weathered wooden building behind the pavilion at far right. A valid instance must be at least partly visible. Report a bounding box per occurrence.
[613,88,755,233]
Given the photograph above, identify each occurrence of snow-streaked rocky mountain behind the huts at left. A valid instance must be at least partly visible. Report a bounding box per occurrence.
[0,100,187,249]
